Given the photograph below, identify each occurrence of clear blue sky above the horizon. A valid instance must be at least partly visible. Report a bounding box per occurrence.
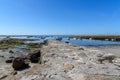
[0,0,120,35]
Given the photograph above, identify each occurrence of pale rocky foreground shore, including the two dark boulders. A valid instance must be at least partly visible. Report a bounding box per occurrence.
[0,40,120,80]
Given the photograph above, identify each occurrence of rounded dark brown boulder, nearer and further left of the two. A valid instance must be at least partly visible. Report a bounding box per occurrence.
[12,57,29,70]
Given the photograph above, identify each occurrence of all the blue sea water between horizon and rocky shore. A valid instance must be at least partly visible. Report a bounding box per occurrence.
[0,35,120,46]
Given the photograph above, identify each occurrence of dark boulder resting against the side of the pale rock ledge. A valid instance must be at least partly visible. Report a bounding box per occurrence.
[28,50,41,63]
